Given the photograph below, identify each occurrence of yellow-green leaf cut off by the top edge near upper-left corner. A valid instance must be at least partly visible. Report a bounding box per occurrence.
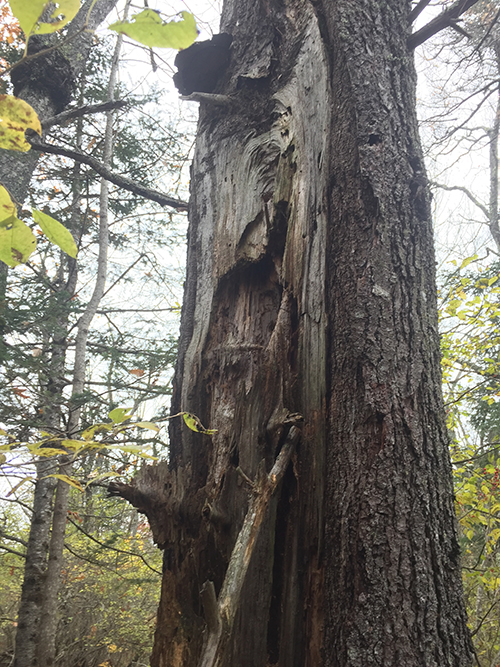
[9,0,80,37]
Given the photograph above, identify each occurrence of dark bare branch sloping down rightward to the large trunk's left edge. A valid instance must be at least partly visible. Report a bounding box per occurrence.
[27,136,188,211]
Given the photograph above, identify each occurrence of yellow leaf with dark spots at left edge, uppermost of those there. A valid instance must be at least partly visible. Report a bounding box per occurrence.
[0,95,42,153]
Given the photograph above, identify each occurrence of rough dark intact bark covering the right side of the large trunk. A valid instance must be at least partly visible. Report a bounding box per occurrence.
[325,2,470,667]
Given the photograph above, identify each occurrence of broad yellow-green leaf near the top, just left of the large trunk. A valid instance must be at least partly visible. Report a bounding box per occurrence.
[109,9,198,49]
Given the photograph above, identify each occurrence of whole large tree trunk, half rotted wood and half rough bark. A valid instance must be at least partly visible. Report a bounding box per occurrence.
[115,0,471,667]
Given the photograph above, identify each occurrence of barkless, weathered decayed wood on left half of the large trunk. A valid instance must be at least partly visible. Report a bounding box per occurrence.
[152,3,332,667]
